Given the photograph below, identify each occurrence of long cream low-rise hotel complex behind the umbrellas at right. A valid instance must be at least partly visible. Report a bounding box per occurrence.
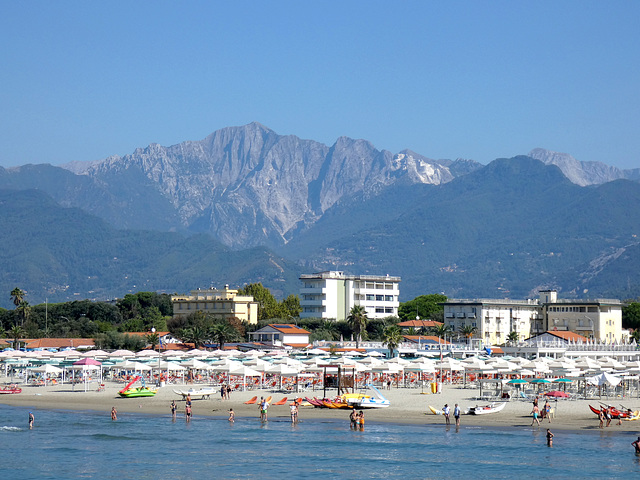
[443,290,622,344]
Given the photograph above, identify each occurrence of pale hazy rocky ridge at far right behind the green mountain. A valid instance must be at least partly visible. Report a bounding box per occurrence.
[529,148,640,186]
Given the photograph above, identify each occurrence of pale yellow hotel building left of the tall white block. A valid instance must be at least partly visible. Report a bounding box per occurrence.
[171,285,258,324]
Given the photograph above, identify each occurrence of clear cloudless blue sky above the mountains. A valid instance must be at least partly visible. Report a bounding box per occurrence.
[0,1,640,168]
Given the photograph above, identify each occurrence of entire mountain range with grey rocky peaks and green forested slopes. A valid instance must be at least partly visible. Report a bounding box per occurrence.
[0,123,640,308]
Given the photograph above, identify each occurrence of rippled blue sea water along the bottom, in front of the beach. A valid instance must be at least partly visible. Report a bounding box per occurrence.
[0,406,640,480]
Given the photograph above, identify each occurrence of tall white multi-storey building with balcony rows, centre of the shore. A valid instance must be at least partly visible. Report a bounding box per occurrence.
[300,271,400,320]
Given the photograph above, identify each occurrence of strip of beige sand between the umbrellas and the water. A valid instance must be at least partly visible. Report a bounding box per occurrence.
[0,383,640,433]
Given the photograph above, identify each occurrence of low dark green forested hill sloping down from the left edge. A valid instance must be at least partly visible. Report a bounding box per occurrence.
[0,190,301,307]
